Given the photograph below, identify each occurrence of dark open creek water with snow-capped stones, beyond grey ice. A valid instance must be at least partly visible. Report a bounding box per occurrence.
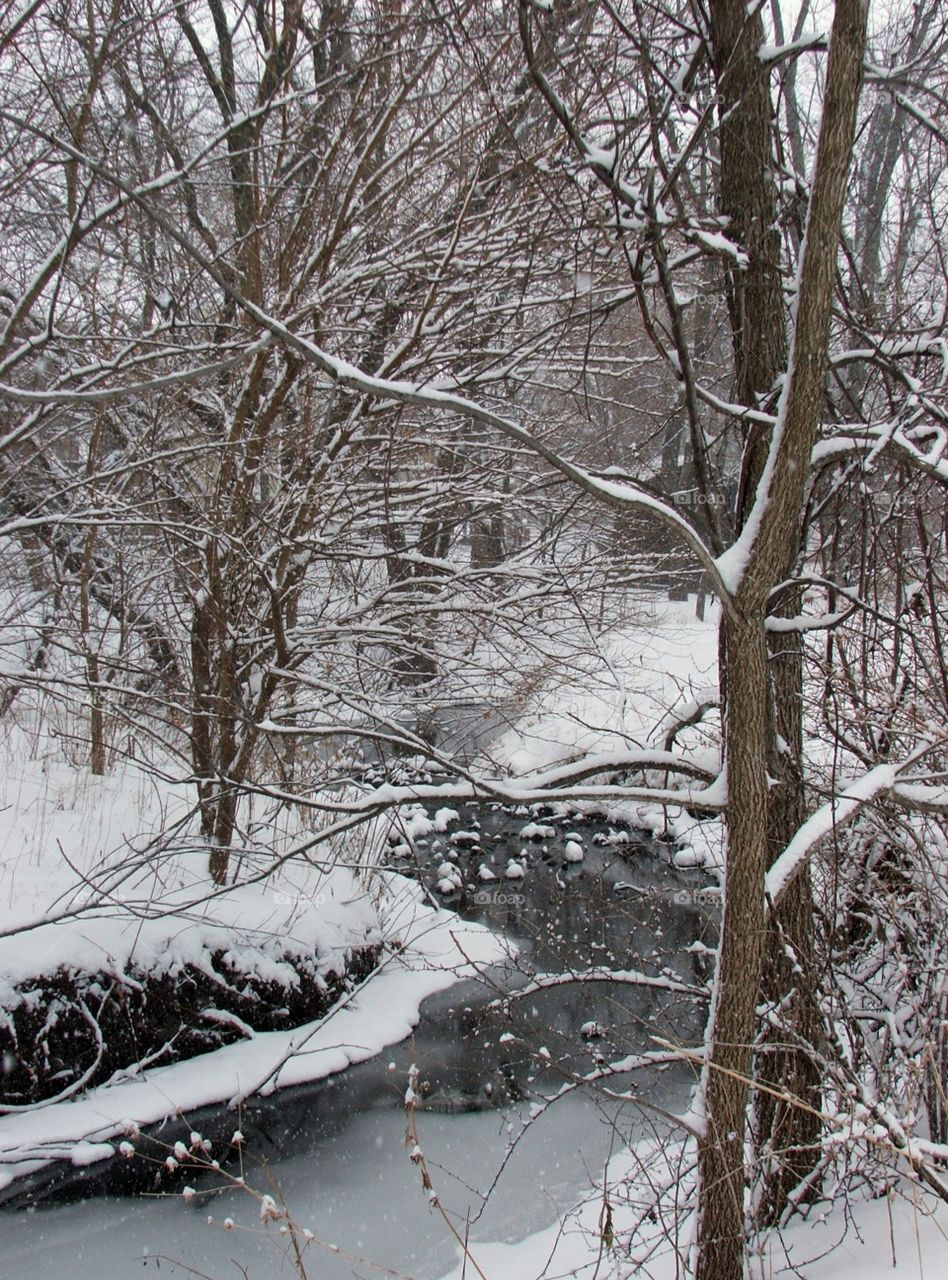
[381,805,716,1108]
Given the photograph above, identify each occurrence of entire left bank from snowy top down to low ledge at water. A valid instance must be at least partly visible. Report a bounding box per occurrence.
[0,726,505,1187]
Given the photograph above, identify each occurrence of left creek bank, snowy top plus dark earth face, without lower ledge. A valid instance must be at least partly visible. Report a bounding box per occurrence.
[0,716,381,1095]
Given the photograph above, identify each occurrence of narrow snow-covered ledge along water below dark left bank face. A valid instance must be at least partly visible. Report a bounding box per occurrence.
[0,879,508,1187]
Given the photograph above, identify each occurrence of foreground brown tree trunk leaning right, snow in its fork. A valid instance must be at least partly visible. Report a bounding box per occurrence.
[696,0,867,1280]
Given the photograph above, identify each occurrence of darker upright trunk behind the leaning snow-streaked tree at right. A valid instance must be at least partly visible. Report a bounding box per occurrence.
[711,0,820,1221]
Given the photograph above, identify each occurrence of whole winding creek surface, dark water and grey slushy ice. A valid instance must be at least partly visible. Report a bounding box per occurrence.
[0,808,714,1280]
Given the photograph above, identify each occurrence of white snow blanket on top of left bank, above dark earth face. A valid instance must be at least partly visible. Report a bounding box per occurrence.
[0,751,377,1007]
